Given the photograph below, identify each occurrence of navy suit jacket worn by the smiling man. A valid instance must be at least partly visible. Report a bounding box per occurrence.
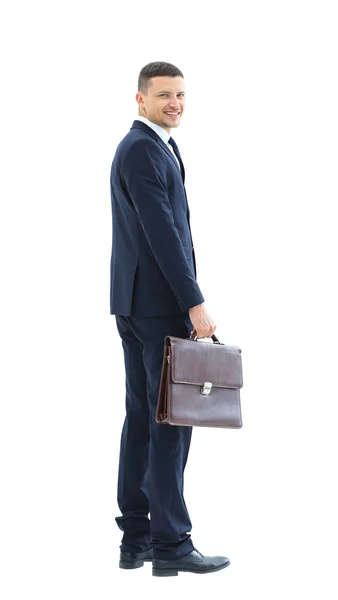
[110,120,204,317]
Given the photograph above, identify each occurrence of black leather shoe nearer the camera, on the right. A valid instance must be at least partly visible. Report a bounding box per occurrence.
[153,548,230,577]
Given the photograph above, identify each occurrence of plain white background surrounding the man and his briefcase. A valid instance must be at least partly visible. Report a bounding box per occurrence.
[0,0,338,600]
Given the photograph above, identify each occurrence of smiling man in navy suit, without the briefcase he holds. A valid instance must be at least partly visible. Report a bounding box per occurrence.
[110,62,229,576]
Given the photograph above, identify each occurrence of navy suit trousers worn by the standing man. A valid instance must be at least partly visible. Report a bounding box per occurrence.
[115,313,194,560]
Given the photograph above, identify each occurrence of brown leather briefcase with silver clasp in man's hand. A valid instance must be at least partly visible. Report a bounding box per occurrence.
[155,334,243,428]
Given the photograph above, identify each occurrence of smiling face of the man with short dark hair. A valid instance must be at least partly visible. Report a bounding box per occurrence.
[136,77,185,133]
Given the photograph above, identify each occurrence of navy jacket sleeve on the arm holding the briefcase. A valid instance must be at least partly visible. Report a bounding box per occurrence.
[121,140,204,311]
